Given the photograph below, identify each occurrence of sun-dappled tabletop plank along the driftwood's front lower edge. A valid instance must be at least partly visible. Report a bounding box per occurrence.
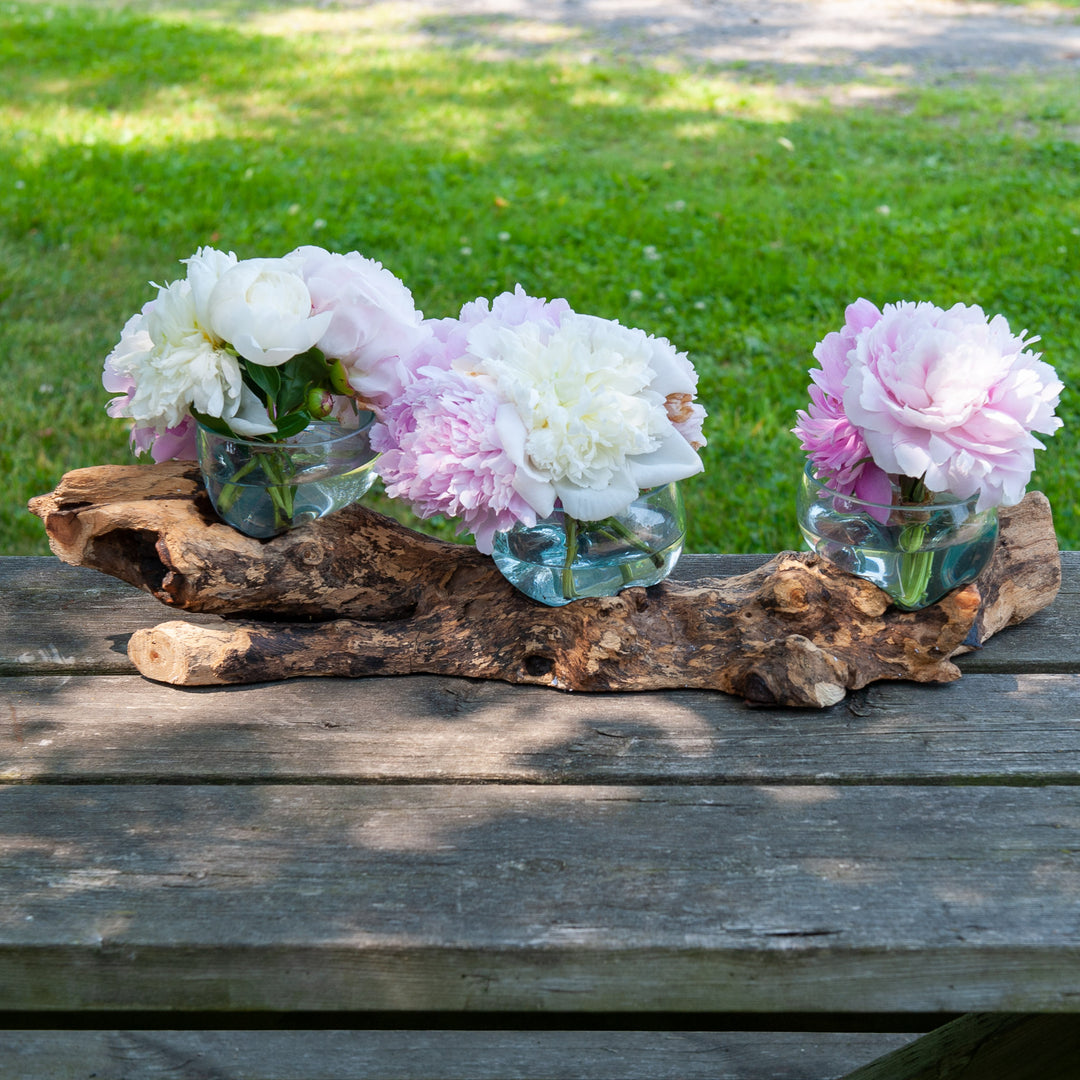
[0,675,1080,784]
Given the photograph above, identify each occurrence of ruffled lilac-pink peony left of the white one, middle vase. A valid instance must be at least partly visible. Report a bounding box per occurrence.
[372,368,536,554]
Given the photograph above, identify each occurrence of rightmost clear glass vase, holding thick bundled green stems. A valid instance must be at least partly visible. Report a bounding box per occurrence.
[797,462,998,611]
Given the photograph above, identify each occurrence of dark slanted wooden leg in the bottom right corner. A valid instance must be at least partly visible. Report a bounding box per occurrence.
[843,1013,1080,1080]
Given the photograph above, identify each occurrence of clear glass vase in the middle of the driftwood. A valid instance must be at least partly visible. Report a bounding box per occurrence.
[491,484,686,607]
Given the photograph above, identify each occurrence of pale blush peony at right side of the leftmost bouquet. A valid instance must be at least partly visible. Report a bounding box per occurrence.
[289,245,432,408]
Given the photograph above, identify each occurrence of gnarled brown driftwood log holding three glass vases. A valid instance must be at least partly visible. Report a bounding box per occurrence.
[30,462,1061,707]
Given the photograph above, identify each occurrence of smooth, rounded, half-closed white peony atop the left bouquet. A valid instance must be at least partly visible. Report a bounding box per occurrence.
[205,258,332,367]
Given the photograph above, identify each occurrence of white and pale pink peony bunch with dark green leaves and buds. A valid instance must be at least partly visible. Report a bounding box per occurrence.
[103,247,427,461]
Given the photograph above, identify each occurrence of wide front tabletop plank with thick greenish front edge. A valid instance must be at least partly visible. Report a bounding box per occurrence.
[0,784,1080,1013]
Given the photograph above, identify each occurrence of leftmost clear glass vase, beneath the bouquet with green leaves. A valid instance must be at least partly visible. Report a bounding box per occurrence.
[197,413,378,539]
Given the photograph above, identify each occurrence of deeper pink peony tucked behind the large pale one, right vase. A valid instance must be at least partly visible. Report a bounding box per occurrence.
[793,299,892,503]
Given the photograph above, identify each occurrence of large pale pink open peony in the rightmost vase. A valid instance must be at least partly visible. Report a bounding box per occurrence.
[842,301,1063,510]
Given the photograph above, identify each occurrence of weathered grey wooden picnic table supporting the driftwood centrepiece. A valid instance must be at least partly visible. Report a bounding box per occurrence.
[0,552,1080,1080]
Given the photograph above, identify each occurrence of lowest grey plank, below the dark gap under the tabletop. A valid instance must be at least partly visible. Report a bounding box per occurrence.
[0,1030,914,1080]
